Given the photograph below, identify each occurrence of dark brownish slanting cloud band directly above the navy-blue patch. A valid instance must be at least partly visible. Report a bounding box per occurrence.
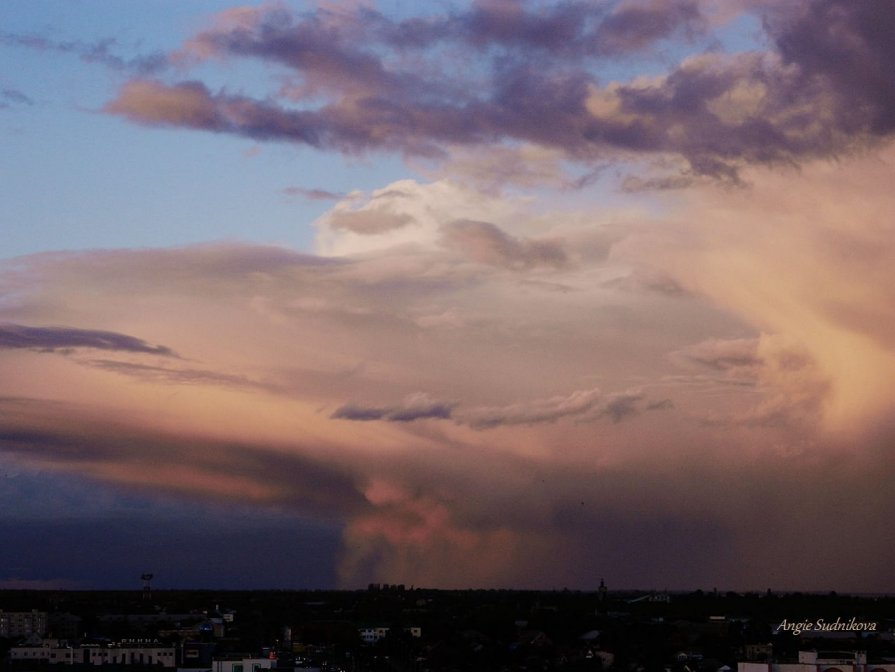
[0,398,364,519]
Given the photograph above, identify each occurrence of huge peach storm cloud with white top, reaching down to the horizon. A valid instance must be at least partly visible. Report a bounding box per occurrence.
[8,142,895,591]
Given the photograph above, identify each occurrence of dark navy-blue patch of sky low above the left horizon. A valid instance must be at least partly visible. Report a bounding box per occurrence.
[0,455,340,590]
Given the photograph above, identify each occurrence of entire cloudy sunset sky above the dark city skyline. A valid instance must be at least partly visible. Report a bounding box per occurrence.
[0,0,895,592]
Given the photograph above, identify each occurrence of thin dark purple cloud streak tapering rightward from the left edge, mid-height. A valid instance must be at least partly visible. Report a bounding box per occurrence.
[0,323,176,357]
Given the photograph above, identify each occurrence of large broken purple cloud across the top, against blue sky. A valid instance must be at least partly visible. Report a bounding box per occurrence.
[105,0,895,178]
